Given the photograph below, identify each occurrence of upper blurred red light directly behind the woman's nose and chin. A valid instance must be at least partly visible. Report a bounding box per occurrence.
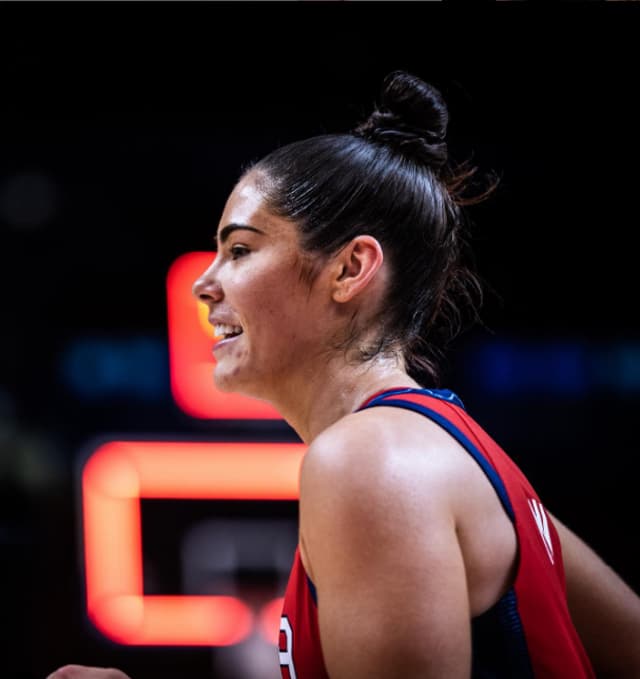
[167,252,281,420]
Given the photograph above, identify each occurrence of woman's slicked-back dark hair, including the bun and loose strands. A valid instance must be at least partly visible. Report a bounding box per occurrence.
[250,71,485,384]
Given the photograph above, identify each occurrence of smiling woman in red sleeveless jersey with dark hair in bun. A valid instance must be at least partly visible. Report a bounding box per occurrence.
[50,72,640,679]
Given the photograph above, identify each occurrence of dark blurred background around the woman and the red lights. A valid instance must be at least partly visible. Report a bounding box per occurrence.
[0,2,640,679]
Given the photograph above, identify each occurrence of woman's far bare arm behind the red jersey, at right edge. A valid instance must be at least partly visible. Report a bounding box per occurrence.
[554,517,640,677]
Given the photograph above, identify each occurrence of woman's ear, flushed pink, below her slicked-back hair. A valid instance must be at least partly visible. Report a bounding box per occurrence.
[332,236,384,304]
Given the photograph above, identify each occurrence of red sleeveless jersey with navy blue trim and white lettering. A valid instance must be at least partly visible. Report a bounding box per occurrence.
[279,389,595,679]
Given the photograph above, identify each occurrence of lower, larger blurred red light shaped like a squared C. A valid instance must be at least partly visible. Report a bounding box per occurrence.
[82,441,305,646]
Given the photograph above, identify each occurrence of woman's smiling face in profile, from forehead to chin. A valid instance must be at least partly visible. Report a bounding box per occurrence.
[193,173,331,398]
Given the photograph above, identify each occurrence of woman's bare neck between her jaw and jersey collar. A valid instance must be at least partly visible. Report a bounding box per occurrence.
[269,357,420,444]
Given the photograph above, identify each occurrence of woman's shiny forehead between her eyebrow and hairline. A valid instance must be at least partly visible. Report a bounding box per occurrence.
[218,173,297,236]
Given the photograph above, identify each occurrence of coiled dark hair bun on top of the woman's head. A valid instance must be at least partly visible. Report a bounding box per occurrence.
[354,71,449,168]
